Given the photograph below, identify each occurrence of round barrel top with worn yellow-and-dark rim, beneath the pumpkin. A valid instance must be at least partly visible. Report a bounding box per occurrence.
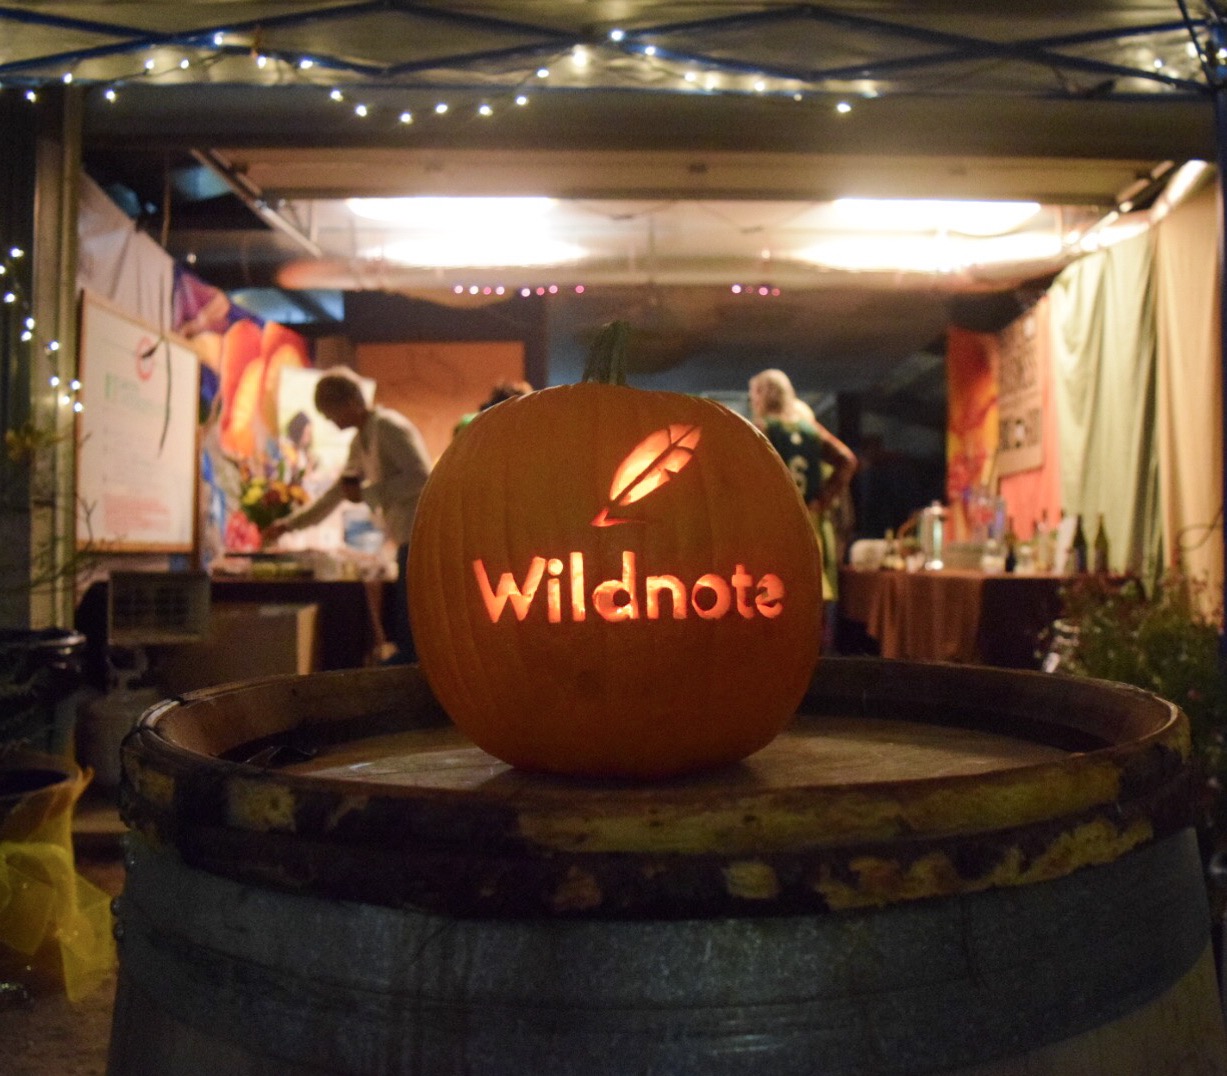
[120,658,1191,918]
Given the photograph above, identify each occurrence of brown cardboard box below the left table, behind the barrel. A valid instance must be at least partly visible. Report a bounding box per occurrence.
[157,601,319,694]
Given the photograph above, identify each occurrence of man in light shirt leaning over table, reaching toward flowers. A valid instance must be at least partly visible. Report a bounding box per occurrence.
[263,367,431,664]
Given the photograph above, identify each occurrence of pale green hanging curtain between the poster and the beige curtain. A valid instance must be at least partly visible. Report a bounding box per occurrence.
[1049,232,1162,580]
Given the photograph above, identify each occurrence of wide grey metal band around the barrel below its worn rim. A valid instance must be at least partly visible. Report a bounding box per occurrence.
[112,831,1209,1076]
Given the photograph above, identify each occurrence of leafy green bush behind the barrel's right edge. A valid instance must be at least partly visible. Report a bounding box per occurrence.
[1061,572,1227,833]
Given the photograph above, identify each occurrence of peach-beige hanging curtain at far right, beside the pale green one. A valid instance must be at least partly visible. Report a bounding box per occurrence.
[1155,177,1223,617]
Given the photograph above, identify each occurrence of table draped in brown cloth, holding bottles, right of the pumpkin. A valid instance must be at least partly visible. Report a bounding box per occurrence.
[839,568,1067,669]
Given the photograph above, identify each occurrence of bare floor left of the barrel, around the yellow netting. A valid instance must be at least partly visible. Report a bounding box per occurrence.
[0,789,124,1076]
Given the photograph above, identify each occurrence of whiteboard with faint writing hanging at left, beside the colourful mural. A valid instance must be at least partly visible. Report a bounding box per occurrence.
[77,292,200,553]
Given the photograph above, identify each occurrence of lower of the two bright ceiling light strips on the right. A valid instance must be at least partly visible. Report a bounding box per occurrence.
[795,233,1063,272]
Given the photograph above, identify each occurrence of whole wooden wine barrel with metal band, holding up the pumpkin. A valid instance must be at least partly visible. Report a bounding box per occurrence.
[108,659,1227,1076]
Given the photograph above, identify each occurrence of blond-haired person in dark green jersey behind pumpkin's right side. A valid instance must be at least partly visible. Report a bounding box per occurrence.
[750,369,856,648]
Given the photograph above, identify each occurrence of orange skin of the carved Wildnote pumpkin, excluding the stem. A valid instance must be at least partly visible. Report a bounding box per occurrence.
[409,383,822,778]
